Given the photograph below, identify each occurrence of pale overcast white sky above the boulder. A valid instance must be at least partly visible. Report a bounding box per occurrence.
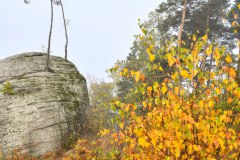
[0,0,162,80]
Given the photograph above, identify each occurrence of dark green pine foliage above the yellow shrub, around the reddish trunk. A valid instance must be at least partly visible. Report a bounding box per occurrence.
[156,0,236,50]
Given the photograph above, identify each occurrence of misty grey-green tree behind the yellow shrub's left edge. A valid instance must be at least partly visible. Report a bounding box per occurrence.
[111,21,170,102]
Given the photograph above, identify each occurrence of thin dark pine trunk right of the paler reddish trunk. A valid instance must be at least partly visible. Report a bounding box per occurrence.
[202,0,211,72]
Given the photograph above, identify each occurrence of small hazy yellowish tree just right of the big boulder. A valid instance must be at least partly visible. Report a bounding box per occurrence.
[87,76,115,134]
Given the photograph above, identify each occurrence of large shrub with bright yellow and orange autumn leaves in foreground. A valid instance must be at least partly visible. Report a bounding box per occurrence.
[99,27,240,160]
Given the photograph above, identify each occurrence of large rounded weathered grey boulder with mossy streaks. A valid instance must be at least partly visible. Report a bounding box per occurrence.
[0,53,89,155]
